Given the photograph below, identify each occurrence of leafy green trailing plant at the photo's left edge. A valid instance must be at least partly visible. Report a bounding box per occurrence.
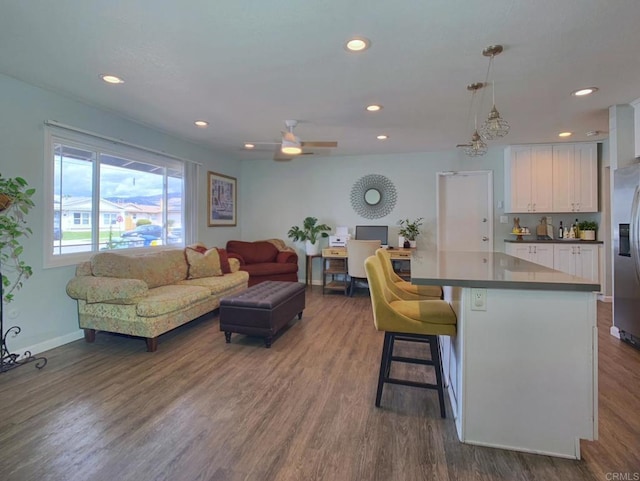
[0,174,36,303]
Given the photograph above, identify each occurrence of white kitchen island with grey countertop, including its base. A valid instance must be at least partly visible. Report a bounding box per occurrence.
[411,251,600,459]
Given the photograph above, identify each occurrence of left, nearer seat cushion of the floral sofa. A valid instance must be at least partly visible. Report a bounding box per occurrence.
[136,285,211,317]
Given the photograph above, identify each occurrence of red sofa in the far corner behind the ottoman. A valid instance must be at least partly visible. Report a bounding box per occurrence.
[226,239,298,287]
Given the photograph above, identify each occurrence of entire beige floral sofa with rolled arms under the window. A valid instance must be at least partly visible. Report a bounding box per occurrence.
[67,245,249,352]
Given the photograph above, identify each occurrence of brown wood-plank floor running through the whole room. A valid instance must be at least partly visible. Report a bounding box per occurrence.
[0,286,640,481]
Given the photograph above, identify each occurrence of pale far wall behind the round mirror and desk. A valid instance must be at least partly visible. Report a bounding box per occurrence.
[239,147,511,282]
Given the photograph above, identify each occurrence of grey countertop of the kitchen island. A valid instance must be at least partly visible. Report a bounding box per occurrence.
[411,249,600,292]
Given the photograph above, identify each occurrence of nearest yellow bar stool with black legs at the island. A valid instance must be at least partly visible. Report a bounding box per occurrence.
[365,256,457,418]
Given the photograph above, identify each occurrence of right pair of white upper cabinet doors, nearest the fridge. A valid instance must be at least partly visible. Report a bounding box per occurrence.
[552,143,598,212]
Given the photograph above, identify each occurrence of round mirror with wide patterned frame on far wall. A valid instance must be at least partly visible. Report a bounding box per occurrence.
[351,174,397,219]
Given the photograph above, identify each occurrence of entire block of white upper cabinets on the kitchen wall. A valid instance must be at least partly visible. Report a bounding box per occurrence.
[504,143,598,213]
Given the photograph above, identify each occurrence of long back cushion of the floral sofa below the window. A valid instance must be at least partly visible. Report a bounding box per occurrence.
[91,249,188,289]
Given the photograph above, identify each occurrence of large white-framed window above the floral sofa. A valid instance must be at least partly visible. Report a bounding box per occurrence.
[45,127,187,265]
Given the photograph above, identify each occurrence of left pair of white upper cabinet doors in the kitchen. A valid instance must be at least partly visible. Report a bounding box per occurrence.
[504,145,553,212]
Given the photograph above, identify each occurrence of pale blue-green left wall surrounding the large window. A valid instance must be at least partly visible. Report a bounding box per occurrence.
[0,75,241,354]
